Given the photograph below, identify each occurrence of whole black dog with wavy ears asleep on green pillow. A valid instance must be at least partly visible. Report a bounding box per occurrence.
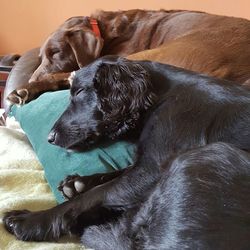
[4,57,250,249]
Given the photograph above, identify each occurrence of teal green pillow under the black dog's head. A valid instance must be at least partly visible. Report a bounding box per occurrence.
[10,90,135,203]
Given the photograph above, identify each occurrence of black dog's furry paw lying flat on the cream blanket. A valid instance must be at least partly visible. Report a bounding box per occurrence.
[3,210,66,241]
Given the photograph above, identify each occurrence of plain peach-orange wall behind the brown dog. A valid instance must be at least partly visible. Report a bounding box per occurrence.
[0,0,250,54]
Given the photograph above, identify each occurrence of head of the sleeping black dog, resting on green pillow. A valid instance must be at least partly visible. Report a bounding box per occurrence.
[48,57,155,150]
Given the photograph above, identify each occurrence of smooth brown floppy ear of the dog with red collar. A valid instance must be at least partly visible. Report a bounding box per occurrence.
[66,29,103,68]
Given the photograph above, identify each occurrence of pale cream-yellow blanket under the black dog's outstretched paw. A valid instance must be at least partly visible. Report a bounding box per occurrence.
[0,118,82,250]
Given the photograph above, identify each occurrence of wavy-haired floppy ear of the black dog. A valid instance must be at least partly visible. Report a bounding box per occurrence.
[95,59,155,117]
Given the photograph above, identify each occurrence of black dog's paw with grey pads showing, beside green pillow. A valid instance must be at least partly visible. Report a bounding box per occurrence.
[58,174,86,199]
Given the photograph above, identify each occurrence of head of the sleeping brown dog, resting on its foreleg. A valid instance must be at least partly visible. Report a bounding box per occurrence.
[30,17,103,82]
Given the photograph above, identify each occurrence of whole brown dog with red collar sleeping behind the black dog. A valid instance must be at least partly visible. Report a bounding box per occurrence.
[8,10,250,104]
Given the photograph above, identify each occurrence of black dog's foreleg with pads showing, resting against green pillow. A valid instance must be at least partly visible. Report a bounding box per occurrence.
[58,166,131,200]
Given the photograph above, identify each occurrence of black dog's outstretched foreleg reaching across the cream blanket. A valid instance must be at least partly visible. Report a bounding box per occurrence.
[3,155,158,241]
